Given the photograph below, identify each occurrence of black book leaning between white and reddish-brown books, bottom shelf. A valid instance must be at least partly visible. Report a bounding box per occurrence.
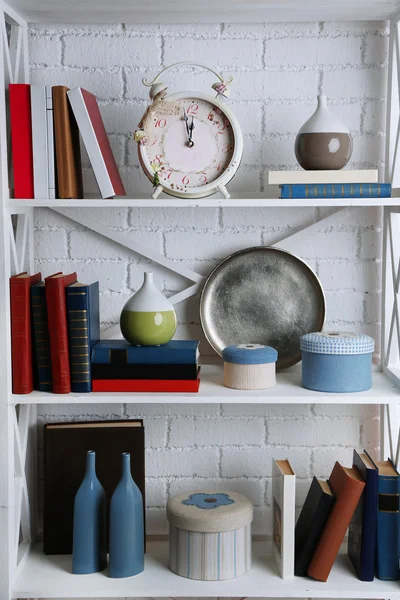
[294,477,335,577]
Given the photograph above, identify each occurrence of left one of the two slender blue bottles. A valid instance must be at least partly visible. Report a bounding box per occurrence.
[72,450,107,575]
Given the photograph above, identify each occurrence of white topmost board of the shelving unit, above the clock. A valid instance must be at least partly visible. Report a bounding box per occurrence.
[9,0,400,23]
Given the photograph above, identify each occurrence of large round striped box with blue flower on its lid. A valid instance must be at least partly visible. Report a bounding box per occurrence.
[167,491,253,581]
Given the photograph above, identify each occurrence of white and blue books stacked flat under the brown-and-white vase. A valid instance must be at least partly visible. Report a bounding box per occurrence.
[268,169,392,199]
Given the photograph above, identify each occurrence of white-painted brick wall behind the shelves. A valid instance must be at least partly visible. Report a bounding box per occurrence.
[30,23,388,533]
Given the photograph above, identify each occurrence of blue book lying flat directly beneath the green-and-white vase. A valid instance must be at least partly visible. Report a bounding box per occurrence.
[92,340,200,365]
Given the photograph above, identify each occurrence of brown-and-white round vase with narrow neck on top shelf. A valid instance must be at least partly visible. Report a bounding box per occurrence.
[295,96,353,171]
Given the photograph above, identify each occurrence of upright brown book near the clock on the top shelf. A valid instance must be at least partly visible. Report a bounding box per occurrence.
[53,85,83,198]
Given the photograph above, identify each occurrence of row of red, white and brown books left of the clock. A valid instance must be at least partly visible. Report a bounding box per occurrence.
[9,83,125,200]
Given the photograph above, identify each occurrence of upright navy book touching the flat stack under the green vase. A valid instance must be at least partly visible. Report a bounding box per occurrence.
[65,281,100,393]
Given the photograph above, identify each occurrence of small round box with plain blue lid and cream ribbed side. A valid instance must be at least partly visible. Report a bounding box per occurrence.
[222,344,278,390]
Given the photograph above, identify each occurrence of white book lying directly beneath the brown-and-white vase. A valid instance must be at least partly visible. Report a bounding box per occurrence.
[268,169,378,185]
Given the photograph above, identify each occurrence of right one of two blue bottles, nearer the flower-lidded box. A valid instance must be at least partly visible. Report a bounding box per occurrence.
[109,452,144,578]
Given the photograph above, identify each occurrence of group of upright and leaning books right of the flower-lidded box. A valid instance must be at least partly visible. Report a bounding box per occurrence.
[273,450,400,581]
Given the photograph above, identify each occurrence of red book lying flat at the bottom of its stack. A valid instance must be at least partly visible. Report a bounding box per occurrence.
[92,379,200,394]
